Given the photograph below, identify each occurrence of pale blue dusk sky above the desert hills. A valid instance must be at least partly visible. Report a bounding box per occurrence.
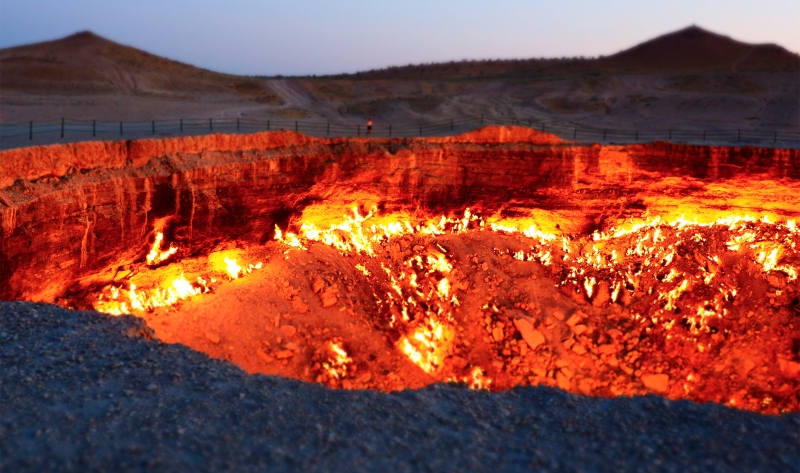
[0,0,800,75]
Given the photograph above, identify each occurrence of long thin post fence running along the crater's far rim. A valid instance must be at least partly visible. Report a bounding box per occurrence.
[0,115,800,149]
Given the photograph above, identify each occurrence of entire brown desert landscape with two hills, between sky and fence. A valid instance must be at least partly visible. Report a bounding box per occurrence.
[0,26,800,135]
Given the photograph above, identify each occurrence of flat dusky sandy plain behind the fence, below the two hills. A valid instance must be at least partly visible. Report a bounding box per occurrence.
[0,73,800,131]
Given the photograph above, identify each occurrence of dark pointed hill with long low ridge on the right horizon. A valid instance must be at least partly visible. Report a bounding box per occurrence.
[336,26,800,80]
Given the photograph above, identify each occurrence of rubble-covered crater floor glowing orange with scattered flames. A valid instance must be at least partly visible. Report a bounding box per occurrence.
[79,207,800,413]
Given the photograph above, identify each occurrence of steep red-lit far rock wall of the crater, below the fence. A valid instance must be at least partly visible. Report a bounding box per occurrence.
[0,127,800,302]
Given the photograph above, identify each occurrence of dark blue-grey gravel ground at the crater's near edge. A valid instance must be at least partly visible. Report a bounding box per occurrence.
[0,302,800,472]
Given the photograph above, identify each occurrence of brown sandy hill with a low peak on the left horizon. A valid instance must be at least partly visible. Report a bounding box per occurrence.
[0,32,277,101]
